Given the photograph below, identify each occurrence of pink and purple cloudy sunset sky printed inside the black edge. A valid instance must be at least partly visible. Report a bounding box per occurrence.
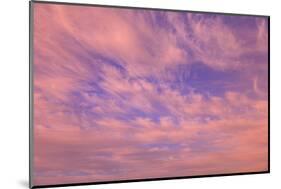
[33,3,268,185]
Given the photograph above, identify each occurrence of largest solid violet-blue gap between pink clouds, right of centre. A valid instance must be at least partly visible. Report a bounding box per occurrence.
[164,62,240,97]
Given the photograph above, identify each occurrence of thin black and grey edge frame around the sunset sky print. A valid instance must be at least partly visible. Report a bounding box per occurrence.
[29,0,270,188]
